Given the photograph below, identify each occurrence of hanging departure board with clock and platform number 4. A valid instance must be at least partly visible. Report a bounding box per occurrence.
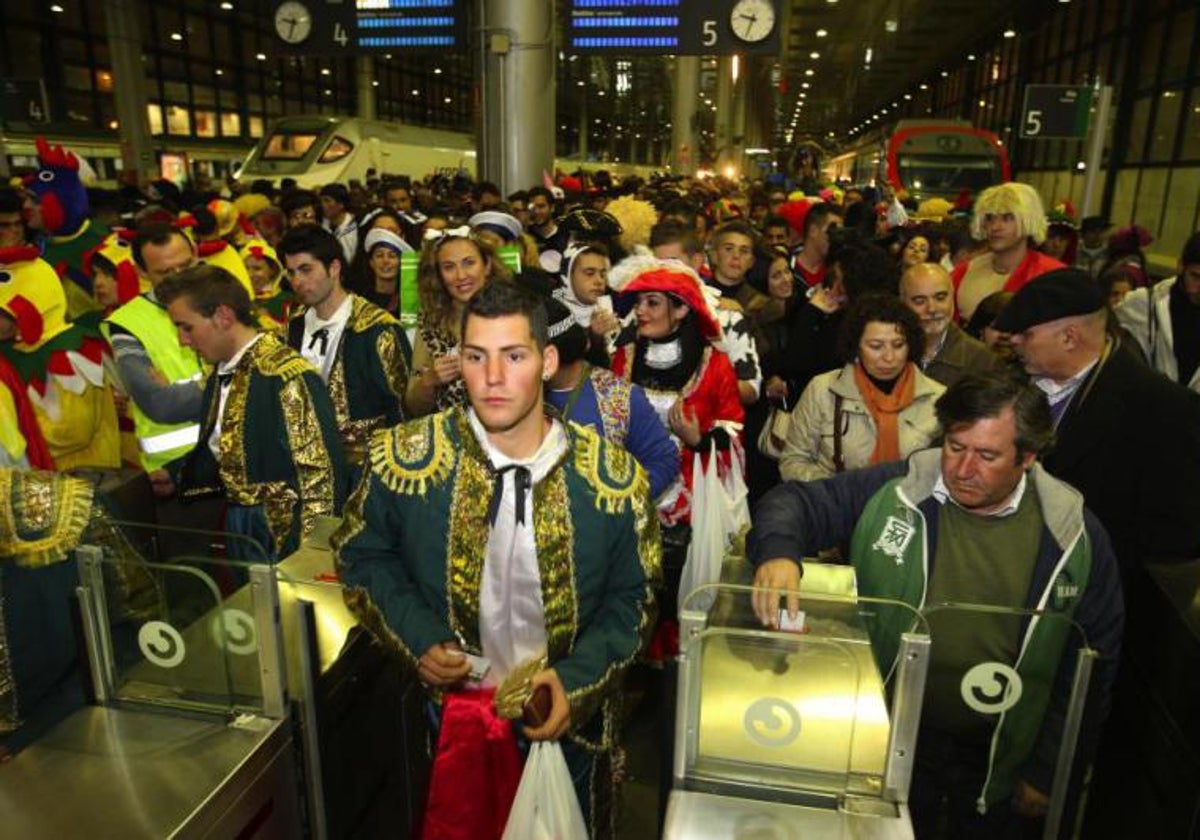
[275,0,468,55]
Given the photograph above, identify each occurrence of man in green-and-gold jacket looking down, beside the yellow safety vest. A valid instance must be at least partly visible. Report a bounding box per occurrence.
[155,265,347,559]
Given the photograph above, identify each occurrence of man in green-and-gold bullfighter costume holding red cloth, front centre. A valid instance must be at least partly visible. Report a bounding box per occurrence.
[334,283,661,838]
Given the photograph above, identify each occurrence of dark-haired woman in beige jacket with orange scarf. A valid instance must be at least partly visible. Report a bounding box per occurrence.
[779,295,946,481]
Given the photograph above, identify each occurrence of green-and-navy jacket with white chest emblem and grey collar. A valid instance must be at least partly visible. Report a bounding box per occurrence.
[748,450,1124,810]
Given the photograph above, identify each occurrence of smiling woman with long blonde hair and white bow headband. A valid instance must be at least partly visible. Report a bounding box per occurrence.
[404,227,512,418]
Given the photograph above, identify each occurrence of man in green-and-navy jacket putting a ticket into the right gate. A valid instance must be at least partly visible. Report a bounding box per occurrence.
[748,374,1124,838]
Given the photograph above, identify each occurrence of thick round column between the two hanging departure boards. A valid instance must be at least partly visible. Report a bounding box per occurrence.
[479,0,554,193]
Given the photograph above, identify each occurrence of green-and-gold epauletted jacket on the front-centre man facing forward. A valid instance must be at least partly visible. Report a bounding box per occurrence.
[334,408,661,740]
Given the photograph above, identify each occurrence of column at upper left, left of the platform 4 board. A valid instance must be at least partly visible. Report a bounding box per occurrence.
[104,0,158,181]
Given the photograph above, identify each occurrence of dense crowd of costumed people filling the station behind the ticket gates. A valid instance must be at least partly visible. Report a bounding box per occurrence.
[0,141,1200,836]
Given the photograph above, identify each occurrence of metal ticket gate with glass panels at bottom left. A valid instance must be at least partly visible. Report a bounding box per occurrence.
[0,520,427,840]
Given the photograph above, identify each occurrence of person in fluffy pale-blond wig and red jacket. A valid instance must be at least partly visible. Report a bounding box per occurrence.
[950,181,1064,322]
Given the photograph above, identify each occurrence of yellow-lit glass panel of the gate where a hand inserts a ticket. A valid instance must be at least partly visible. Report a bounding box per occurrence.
[677,581,925,800]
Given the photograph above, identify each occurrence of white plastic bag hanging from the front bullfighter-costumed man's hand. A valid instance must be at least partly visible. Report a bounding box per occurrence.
[504,740,588,840]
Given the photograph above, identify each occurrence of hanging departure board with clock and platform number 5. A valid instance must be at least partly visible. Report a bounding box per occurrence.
[564,0,781,55]
